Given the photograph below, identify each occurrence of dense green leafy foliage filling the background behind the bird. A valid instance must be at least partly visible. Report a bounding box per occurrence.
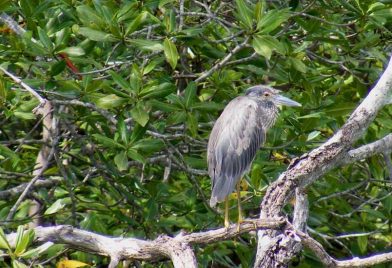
[0,0,392,267]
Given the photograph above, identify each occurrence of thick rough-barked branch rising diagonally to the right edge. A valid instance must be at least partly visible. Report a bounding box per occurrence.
[255,56,392,267]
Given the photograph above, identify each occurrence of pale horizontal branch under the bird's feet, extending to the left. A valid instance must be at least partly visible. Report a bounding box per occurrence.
[7,218,286,268]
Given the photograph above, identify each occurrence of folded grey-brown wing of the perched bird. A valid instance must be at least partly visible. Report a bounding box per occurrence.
[207,97,265,205]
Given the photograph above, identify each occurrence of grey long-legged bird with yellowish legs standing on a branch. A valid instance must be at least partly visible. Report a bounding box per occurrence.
[207,85,301,228]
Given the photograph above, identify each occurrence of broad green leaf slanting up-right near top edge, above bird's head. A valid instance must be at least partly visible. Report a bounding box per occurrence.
[256,9,290,34]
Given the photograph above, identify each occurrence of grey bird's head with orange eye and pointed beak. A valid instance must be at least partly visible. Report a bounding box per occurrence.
[245,85,301,107]
